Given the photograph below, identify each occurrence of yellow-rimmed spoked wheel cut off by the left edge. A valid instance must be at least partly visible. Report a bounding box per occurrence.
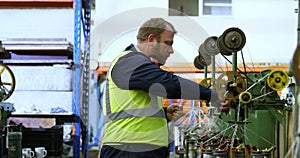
[0,63,16,101]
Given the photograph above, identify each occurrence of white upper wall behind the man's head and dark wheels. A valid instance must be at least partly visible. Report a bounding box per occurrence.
[91,0,298,65]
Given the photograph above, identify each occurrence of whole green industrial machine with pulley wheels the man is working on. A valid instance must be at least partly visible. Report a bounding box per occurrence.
[176,27,299,158]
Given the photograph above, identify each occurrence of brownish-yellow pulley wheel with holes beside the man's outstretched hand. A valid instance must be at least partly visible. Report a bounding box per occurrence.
[215,71,247,100]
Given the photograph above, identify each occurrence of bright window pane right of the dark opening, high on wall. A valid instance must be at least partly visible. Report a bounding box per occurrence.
[202,0,232,15]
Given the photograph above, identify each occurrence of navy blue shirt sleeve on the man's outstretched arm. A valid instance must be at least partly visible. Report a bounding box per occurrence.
[112,45,211,101]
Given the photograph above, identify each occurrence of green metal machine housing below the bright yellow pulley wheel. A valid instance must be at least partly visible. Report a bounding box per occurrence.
[245,70,284,149]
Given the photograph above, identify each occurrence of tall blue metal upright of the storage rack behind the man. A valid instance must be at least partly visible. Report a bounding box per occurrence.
[72,0,92,158]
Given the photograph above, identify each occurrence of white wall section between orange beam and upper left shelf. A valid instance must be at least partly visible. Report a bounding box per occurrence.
[0,8,74,42]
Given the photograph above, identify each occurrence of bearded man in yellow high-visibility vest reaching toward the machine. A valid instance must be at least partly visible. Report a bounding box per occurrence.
[100,18,228,158]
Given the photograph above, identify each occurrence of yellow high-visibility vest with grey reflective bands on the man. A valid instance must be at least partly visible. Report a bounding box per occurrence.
[103,51,168,147]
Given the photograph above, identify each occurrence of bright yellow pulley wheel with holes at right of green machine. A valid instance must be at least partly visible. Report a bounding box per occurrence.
[267,70,289,91]
